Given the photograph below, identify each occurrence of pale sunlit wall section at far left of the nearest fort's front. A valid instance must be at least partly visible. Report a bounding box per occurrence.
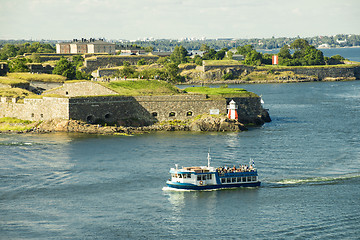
[0,97,69,121]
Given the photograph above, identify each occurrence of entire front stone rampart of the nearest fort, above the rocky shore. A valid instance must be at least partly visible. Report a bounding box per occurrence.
[0,94,267,125]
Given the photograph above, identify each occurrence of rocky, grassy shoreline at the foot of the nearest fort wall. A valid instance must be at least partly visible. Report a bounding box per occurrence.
[0,115,271,135]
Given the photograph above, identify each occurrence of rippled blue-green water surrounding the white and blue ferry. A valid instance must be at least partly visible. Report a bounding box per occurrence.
[0,81,360,239]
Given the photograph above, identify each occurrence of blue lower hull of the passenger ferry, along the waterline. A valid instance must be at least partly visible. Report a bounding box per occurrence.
[166,181,261,190]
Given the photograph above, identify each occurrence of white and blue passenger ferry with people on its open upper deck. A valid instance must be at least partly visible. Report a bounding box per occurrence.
[166,153,261,190]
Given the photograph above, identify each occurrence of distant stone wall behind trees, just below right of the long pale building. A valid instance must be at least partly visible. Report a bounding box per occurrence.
[83,55,159,73]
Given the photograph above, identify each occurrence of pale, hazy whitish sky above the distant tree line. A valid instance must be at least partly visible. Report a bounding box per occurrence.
[0,0,360,40]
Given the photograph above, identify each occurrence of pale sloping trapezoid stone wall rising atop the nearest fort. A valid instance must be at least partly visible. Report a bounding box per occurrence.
[46,81,118,97]
